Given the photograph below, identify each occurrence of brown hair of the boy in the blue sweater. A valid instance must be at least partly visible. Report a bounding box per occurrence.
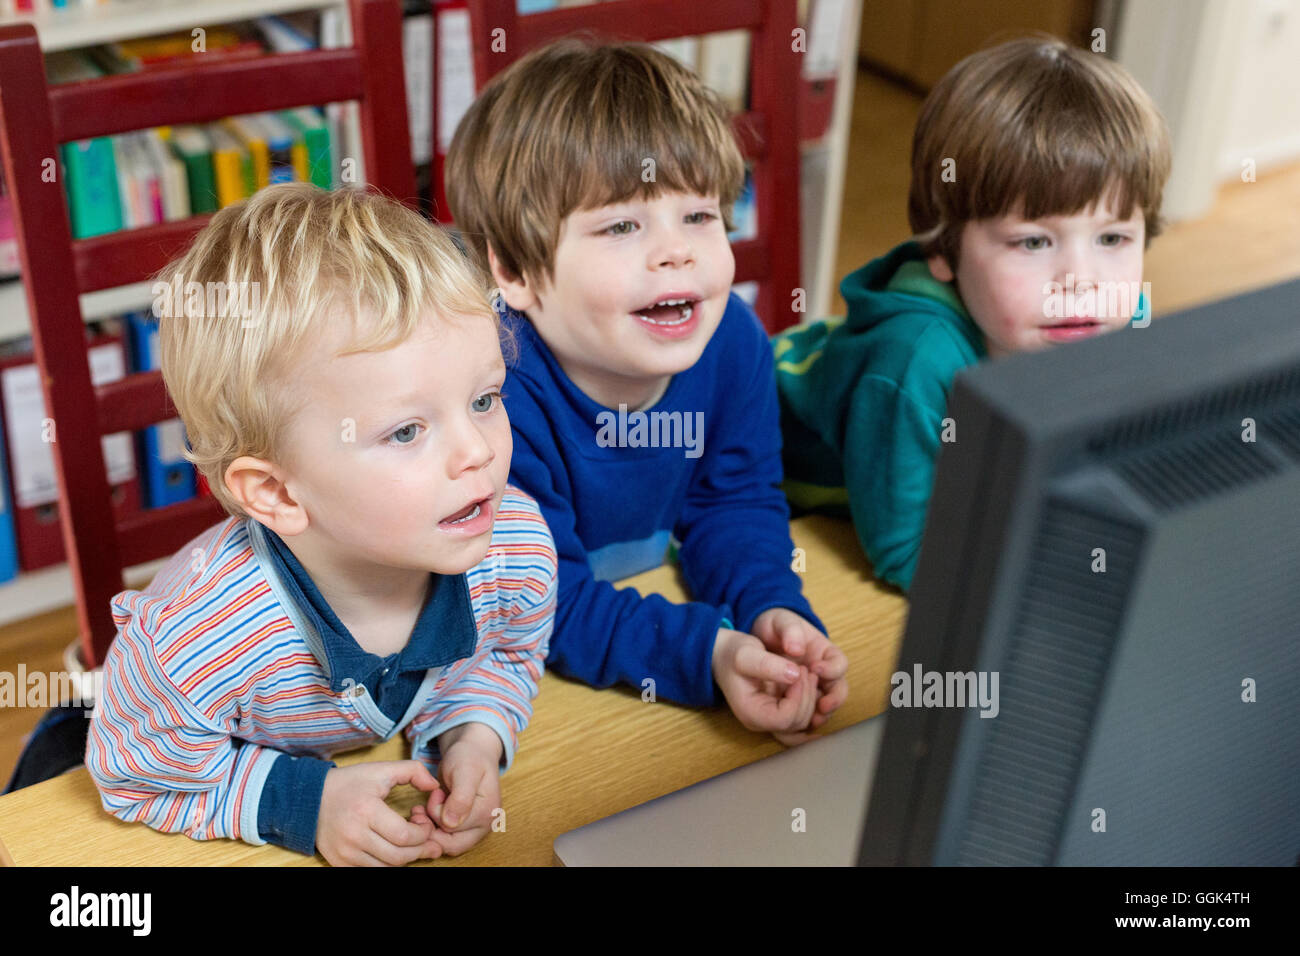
[446,38,745,280]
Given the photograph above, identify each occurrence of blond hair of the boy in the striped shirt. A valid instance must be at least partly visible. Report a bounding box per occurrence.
[153,183,499,515]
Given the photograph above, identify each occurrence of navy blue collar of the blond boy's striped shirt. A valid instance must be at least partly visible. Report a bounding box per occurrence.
[263,525,478,693]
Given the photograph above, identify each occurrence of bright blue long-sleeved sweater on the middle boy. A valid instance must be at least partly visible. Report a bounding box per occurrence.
[503,295,826,706]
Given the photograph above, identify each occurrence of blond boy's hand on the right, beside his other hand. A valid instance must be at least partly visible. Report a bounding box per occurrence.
[411,723,502,856]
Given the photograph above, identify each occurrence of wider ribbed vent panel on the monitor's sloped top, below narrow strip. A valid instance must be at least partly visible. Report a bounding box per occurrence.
[1115,429,1278,510]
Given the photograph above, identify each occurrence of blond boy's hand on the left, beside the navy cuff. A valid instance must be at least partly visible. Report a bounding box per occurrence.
[316,760,442,866]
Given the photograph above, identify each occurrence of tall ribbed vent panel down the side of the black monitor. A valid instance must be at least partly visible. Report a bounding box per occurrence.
[956,498,1141,866]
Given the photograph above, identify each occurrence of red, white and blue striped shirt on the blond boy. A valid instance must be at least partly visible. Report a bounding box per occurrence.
[86,486,556,844]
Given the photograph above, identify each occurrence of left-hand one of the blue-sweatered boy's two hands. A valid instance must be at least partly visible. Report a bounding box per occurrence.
[714,627,816,747]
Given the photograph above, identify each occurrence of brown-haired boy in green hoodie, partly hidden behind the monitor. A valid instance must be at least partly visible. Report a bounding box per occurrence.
[772,38,1170,591]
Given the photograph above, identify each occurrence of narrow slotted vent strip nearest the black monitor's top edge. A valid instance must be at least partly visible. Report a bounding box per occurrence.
[1088,368,1300,453]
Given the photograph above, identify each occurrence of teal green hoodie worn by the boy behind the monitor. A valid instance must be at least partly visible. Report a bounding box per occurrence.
[772,242,988,591]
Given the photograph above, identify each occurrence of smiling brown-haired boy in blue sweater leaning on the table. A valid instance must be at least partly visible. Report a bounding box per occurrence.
[447,40,848,743]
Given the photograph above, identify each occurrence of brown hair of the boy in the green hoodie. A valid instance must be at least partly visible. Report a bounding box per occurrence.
[907,35,1170,269]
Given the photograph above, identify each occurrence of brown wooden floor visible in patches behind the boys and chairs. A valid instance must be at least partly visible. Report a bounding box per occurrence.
[0,74,1300,786]
